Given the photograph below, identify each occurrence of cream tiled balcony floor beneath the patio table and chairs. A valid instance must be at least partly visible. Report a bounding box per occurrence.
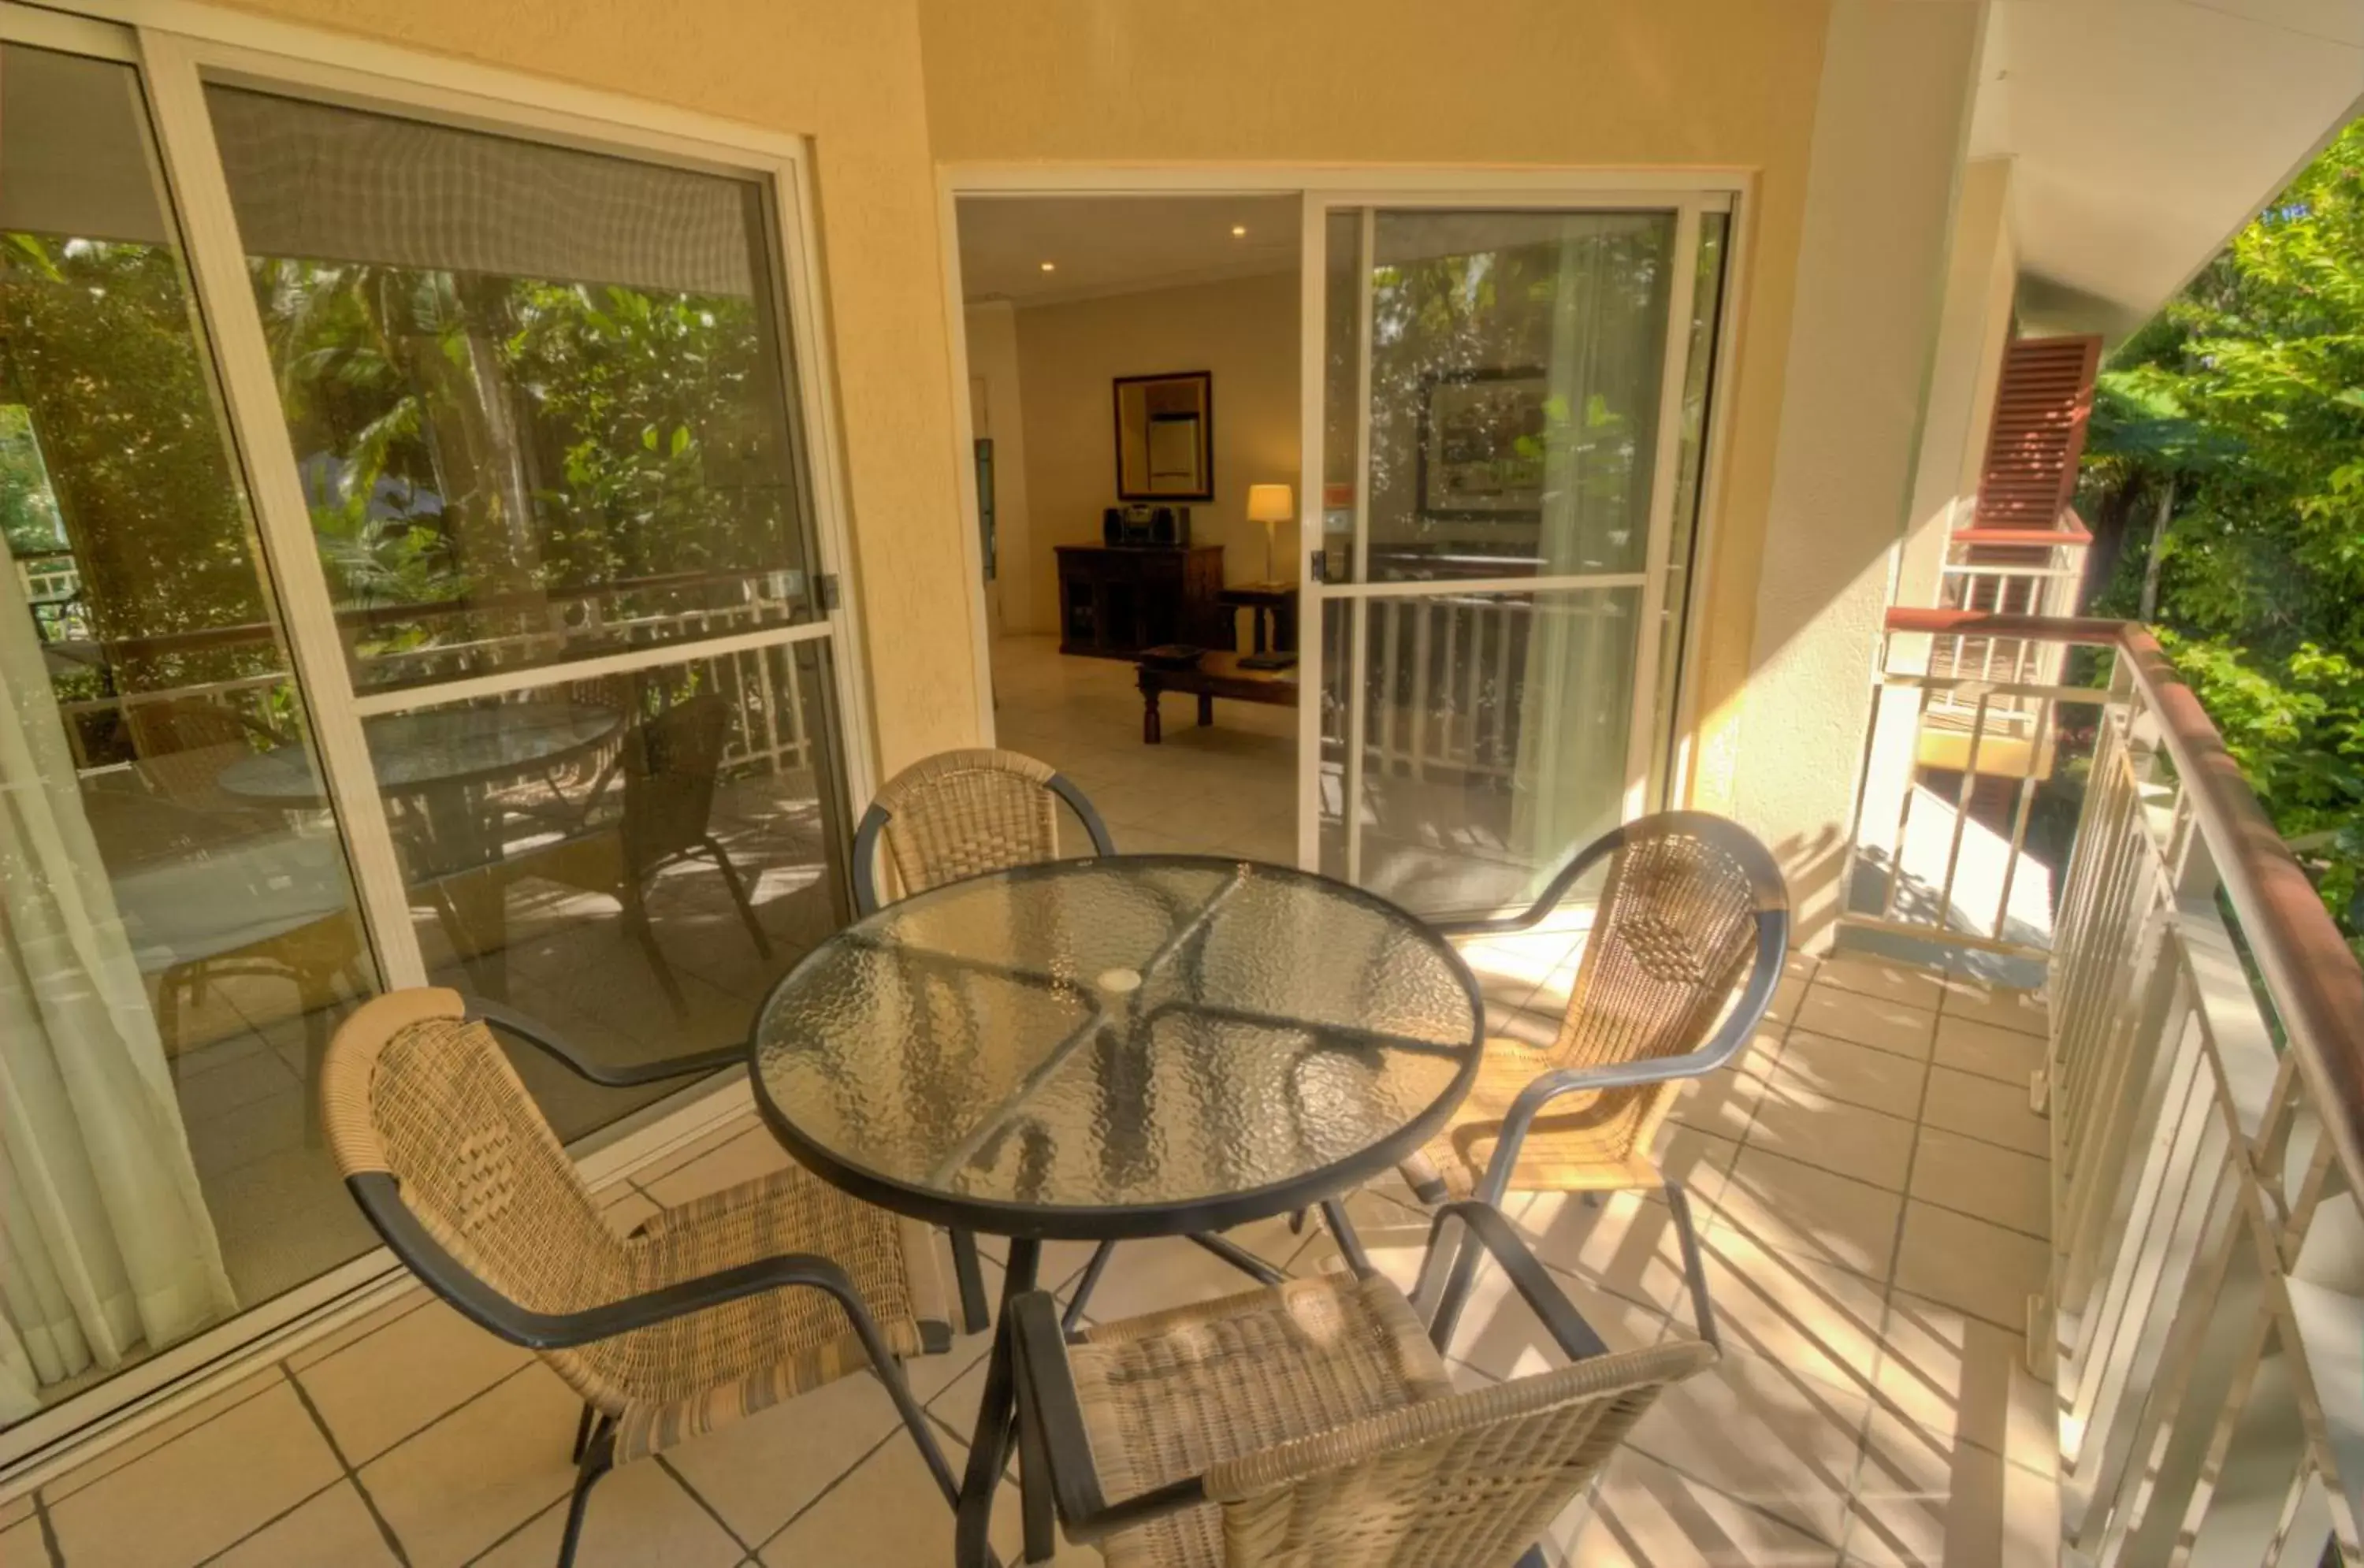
[0,934,2057,1568]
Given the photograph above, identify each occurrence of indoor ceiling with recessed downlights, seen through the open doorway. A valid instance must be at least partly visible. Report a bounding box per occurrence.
[960,196,1298,305]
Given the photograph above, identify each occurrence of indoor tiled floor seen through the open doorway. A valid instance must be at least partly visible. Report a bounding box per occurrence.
[993,636,1298,864]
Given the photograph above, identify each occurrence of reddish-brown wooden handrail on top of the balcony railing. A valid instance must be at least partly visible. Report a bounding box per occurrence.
[1886,608,2364,1192]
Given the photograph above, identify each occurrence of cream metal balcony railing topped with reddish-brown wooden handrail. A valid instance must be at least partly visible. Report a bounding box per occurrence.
[1846,610,2364,1566]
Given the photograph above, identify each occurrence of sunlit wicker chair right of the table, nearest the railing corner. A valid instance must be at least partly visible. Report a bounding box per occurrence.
[1404,812,1790,1332]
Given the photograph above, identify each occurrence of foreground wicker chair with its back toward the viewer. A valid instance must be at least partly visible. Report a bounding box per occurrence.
[1009,1202,1719,1568]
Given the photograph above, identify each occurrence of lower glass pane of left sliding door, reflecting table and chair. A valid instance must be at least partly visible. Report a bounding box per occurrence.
[364,643,846,1138]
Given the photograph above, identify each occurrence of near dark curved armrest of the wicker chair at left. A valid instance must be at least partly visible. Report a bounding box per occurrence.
[345,1171,868,1351]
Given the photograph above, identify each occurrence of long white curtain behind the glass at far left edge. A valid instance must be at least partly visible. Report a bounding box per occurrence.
[0,546,236,1421]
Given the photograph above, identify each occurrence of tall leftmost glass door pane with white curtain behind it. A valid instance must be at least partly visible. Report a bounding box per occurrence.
[0,45,376,1419]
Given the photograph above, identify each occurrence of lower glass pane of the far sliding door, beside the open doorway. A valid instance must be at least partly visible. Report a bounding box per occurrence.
[1317,589,1641,916]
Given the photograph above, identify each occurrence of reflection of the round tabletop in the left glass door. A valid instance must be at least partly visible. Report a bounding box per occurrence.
[220,702,624,802]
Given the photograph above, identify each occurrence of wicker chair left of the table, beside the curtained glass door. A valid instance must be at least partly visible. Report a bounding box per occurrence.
[322,989,957,1568]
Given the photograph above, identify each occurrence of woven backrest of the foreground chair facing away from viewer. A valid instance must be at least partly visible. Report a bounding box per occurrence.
[1210,1341,1716,1568]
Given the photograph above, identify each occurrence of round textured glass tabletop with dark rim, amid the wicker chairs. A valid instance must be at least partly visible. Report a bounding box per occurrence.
[752,856,1482,1239]
